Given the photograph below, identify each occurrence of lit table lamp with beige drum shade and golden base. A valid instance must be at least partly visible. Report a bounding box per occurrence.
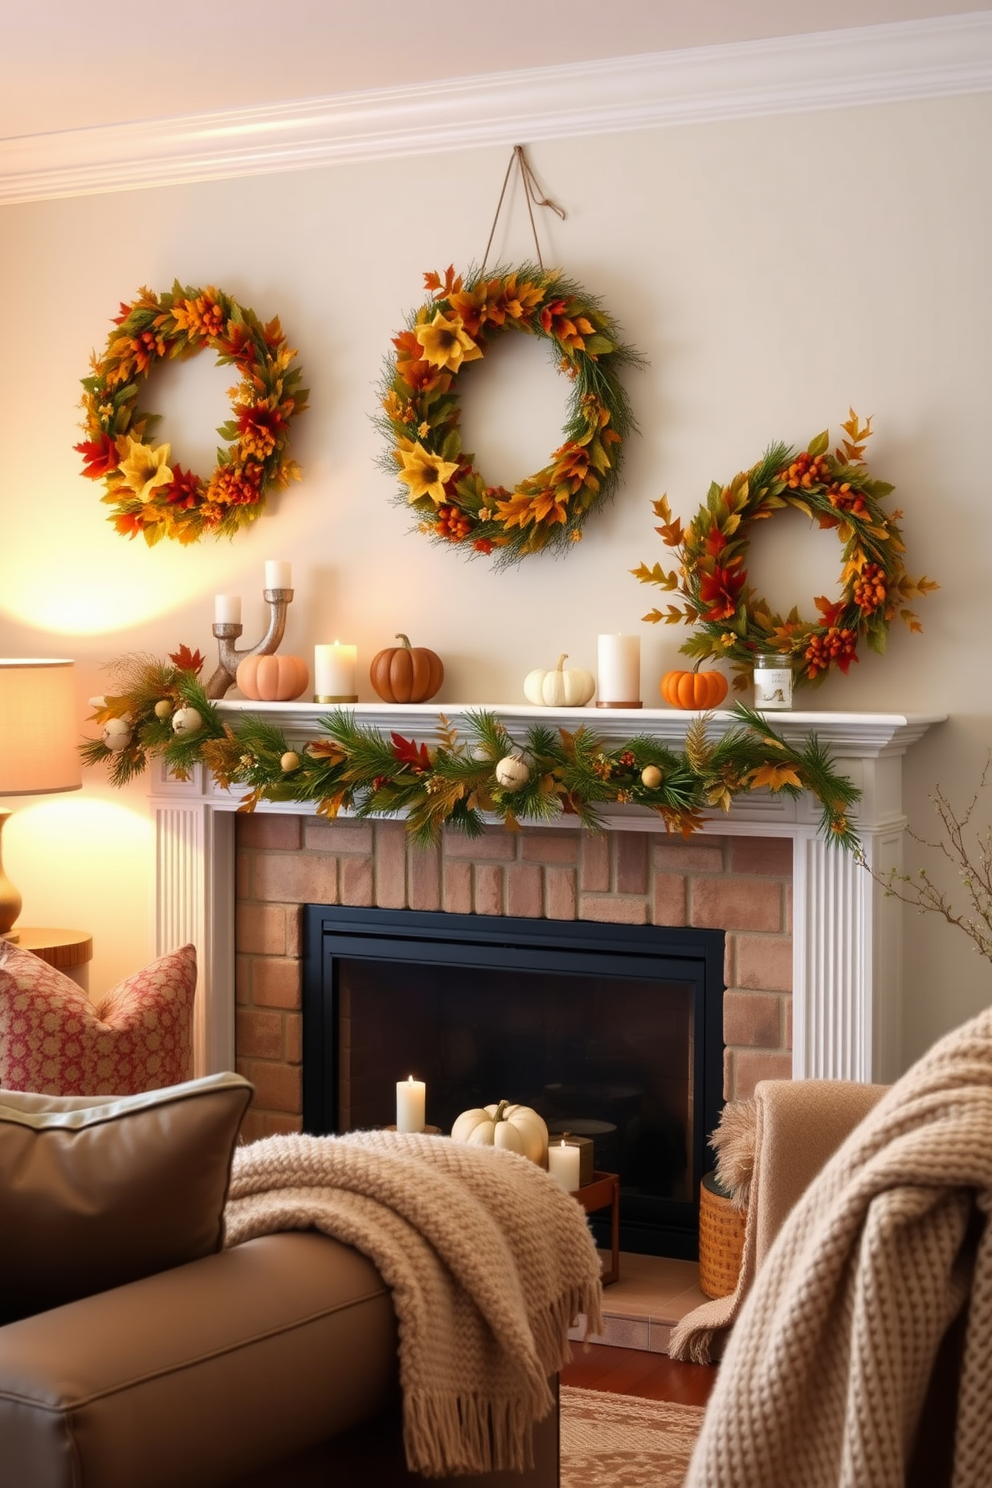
[0,658,83,940]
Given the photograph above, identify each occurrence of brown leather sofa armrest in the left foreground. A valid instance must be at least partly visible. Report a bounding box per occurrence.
[0,1232,397,1488]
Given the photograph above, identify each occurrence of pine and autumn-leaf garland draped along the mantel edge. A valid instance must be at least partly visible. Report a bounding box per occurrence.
[80,647,861,851]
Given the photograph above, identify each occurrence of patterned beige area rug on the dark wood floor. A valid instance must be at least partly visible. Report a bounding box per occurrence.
[561,1385,703,1488]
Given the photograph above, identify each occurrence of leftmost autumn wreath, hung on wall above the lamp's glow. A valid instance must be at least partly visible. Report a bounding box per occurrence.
[76,281,308,545]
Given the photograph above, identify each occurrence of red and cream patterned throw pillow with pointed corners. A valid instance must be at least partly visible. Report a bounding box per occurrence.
[0,940,196,1095]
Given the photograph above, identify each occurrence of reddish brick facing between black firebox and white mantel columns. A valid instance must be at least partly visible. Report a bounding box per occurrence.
[235,815,793,1140]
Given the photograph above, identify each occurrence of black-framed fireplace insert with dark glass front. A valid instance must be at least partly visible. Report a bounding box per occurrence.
[303,905,724,1259]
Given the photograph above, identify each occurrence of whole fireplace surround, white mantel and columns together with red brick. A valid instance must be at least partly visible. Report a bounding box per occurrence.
[152,702,941,1137]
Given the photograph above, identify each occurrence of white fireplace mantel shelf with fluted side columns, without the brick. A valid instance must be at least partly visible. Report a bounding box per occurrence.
[152,702,944,1082]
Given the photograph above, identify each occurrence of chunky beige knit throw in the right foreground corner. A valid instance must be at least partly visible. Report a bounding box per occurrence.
[686,1010,992,1488]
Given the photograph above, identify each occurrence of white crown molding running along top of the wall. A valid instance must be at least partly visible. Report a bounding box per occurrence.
[0,10,992,204]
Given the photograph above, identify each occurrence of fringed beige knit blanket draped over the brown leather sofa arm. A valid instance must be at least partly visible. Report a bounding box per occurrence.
[225,1131,602,1476]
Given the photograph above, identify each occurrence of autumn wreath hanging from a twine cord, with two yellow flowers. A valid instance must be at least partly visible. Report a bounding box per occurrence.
[379,263,641,564]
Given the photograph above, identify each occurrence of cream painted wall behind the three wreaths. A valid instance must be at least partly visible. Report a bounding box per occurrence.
[0,97,992,1058]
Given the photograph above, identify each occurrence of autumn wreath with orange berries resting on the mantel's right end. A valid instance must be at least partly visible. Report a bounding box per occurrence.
[631,409,938,690]
